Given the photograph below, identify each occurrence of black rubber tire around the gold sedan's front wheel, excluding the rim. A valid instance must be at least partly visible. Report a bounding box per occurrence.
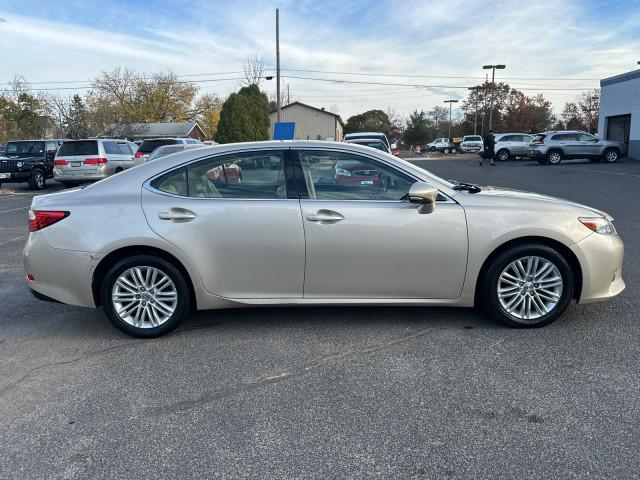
[478,243,575,328]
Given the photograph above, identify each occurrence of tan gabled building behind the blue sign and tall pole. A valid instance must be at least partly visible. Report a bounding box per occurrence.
[269,102,344,142]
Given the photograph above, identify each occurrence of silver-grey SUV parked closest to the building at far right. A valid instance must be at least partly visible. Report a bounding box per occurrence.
[529,130,627,165]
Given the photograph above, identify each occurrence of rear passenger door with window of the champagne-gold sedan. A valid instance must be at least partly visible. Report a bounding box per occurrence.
[142,149,305,298]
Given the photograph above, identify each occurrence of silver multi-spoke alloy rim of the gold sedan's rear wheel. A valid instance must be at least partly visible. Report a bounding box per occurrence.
[111,266,178,328]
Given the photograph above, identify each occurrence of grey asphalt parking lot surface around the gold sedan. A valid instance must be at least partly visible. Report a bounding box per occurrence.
[0,157,640,479]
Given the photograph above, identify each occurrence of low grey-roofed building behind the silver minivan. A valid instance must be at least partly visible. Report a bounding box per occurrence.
[100,122,207,141]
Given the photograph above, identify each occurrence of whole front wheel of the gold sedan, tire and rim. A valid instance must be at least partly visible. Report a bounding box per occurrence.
[480,244,575,328]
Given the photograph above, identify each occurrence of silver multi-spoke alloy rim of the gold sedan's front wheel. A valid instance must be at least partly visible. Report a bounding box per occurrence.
[497,256,564,322]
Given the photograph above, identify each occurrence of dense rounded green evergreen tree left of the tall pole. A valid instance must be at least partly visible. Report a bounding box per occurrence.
[215,85,269,143]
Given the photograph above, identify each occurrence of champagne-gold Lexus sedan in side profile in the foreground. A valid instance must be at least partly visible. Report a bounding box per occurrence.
[24,141,625,337]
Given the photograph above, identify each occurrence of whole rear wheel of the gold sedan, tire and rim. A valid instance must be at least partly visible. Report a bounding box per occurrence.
[101,255,190,338]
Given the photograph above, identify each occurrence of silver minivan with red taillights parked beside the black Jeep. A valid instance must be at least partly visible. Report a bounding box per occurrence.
[53,139,141,186]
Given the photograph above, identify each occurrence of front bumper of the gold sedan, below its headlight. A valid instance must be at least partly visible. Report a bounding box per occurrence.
[571,233,625,304]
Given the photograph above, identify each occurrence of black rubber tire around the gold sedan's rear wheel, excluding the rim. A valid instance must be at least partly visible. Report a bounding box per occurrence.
[100,255,191,338]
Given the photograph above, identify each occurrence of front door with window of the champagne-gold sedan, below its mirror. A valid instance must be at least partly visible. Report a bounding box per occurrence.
[299,149,467,299]
